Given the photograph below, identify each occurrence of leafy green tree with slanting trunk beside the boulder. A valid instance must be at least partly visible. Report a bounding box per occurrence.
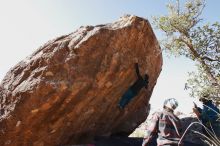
[153,0,220,101]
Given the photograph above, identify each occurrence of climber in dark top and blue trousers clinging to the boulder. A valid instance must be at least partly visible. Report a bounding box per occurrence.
[118,63,149,109]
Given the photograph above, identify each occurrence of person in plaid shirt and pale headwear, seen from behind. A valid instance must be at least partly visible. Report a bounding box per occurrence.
[142,98,182,146]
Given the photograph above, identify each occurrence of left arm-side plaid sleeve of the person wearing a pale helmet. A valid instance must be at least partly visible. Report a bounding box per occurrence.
[142,114,159,146]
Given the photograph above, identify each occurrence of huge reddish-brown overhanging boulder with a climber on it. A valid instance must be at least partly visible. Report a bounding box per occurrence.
[0,16,162,146]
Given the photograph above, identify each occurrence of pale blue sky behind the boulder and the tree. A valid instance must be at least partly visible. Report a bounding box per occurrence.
[0,0,220,111]
